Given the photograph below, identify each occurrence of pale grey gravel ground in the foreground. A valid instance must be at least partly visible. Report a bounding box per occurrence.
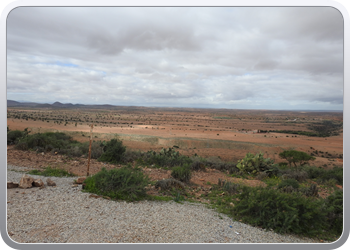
[7,166,326,243]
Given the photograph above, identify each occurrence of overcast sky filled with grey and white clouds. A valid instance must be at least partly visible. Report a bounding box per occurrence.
[7,7,344,110]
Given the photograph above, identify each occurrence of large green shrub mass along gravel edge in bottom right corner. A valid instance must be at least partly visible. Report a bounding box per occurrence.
[209,181,343,241]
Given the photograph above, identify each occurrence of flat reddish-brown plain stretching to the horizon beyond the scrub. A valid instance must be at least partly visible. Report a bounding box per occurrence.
[7,107,343,168]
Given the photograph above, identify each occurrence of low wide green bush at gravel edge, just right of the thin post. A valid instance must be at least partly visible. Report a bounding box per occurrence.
[84,166,149,201]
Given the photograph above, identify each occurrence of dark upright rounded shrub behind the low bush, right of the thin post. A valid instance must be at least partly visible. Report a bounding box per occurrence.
[98,139,126,163]
